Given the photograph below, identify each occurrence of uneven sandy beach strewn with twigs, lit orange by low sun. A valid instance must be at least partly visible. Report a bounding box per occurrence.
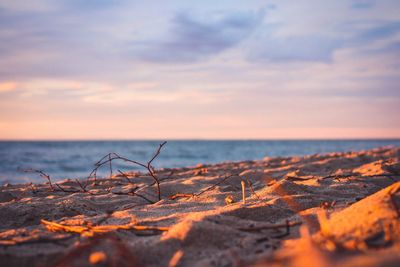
[0,147,400,267]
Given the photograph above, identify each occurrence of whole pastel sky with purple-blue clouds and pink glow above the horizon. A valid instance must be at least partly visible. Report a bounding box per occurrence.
[0,0,400,140]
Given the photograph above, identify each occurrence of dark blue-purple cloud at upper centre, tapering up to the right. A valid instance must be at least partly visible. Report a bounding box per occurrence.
[131,12,264,63]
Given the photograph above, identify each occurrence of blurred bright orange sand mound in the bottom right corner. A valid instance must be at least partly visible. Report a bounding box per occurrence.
[254,182,400,266]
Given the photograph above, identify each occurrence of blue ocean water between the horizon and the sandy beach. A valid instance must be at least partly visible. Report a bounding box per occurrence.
[0,139,400,184]
